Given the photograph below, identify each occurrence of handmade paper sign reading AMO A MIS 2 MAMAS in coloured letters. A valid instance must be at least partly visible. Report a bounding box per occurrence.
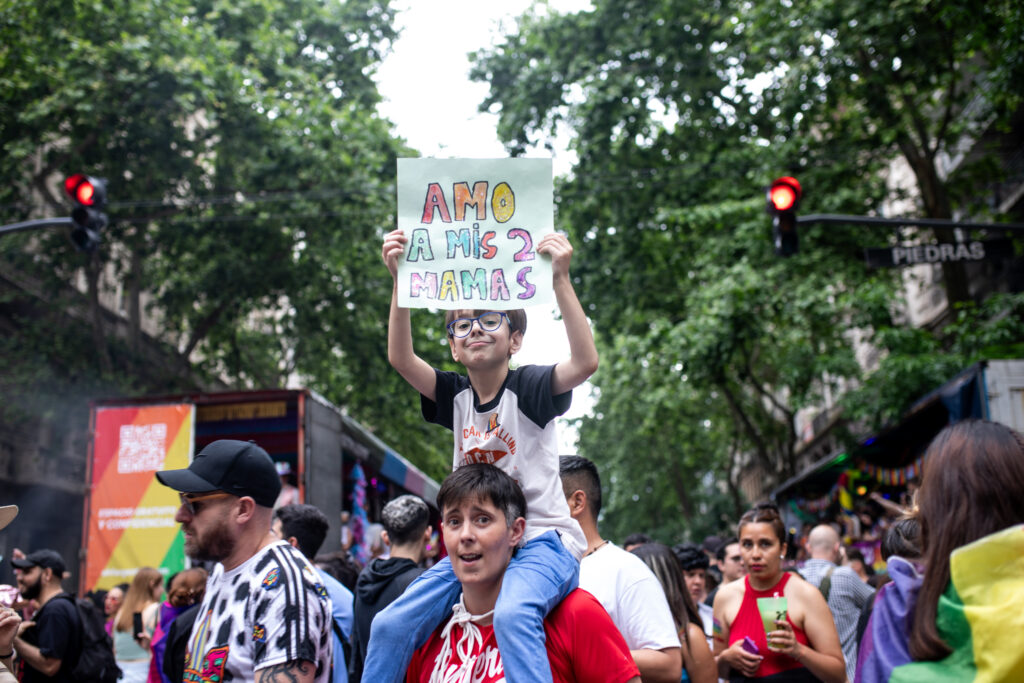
[398,159,554,310]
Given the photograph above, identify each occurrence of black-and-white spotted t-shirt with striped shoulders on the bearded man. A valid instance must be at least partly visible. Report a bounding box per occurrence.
[183,541,333,683]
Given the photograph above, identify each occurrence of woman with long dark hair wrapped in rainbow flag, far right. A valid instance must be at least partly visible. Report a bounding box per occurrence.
[856,420,1024,683]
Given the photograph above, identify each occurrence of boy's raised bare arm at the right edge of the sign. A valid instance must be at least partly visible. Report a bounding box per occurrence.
[537,232,598,396]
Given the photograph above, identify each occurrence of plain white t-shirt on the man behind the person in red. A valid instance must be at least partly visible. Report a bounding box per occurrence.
[580,542,679,650]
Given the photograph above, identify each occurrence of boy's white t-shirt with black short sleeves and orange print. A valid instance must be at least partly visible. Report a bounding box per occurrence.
[421,366,587,559]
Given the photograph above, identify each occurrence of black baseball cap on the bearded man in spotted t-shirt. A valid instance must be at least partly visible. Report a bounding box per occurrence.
[157,439,281,508]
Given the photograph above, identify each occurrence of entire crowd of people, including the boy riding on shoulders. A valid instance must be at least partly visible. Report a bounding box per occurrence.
[0,230,1024,683]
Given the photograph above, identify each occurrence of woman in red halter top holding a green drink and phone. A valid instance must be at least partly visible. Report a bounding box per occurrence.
[714,504,846,683]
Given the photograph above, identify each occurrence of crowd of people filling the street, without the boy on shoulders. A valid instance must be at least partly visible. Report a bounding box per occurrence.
[0,421,1024,683]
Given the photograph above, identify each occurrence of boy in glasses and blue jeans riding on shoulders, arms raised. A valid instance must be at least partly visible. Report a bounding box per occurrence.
[364,222,598,683]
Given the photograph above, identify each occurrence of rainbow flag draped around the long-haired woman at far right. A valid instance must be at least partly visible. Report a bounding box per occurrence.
[856,524,1024,683]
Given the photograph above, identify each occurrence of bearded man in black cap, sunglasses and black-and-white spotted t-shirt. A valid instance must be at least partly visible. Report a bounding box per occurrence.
[157,439,332,683]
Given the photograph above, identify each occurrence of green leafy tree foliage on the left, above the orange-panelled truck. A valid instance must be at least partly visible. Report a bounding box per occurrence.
[0,0,447,476]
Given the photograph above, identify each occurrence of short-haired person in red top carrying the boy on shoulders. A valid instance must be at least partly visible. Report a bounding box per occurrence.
[406,464,630,683]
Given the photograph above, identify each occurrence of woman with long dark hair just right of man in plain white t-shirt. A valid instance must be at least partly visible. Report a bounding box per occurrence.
[630,543,718,683]
